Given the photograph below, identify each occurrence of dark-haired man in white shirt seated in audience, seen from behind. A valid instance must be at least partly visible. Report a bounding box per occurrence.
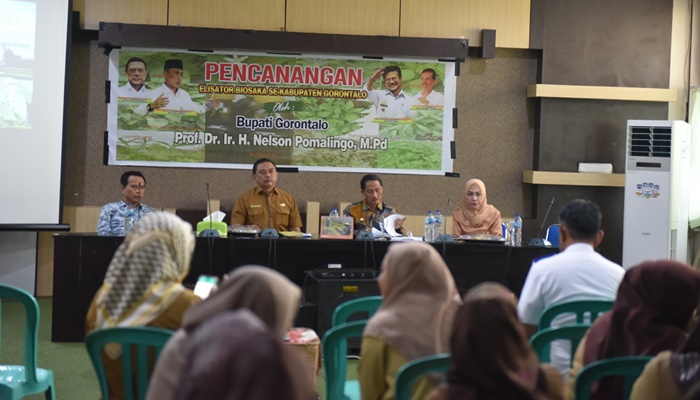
[518,199,625,376]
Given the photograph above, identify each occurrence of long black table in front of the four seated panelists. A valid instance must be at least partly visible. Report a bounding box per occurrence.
[51,233,558,342]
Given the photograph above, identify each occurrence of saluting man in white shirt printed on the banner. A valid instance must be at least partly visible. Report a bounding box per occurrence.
[367,65,420,119]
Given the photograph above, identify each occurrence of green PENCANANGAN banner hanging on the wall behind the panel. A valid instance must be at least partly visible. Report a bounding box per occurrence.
[108,49,455,174]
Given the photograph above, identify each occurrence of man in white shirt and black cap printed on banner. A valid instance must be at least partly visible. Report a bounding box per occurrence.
[136,60,220,115]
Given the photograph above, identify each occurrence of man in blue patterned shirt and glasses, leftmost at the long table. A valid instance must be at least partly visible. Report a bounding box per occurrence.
[97,171,156,236]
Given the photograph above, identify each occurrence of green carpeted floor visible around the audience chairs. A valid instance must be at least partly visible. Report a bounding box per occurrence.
[0,297,357,400]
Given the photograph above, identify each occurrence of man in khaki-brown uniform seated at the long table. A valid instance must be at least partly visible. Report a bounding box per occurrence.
[231,158,302,232]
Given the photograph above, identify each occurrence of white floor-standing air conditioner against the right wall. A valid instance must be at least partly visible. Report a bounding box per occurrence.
[622,120,690,269]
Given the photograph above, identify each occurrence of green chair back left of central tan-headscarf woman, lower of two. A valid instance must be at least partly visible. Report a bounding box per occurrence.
[322,321,367,400]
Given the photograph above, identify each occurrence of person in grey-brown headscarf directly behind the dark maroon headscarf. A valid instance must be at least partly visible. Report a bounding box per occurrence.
[146,266,301,400]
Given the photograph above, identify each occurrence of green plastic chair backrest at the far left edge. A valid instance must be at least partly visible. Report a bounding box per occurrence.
[0,284,39,383]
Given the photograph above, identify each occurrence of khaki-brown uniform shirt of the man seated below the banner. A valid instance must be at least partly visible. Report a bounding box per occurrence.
[231,186,302,231]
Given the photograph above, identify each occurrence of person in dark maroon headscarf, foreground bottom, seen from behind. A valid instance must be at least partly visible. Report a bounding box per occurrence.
[175,309,315,400]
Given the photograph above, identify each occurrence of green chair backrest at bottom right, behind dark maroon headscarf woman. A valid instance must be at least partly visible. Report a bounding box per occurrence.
[575,356,652,400]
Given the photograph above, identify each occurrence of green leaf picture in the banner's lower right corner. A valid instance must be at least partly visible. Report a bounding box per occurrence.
[377,141,442,171]
